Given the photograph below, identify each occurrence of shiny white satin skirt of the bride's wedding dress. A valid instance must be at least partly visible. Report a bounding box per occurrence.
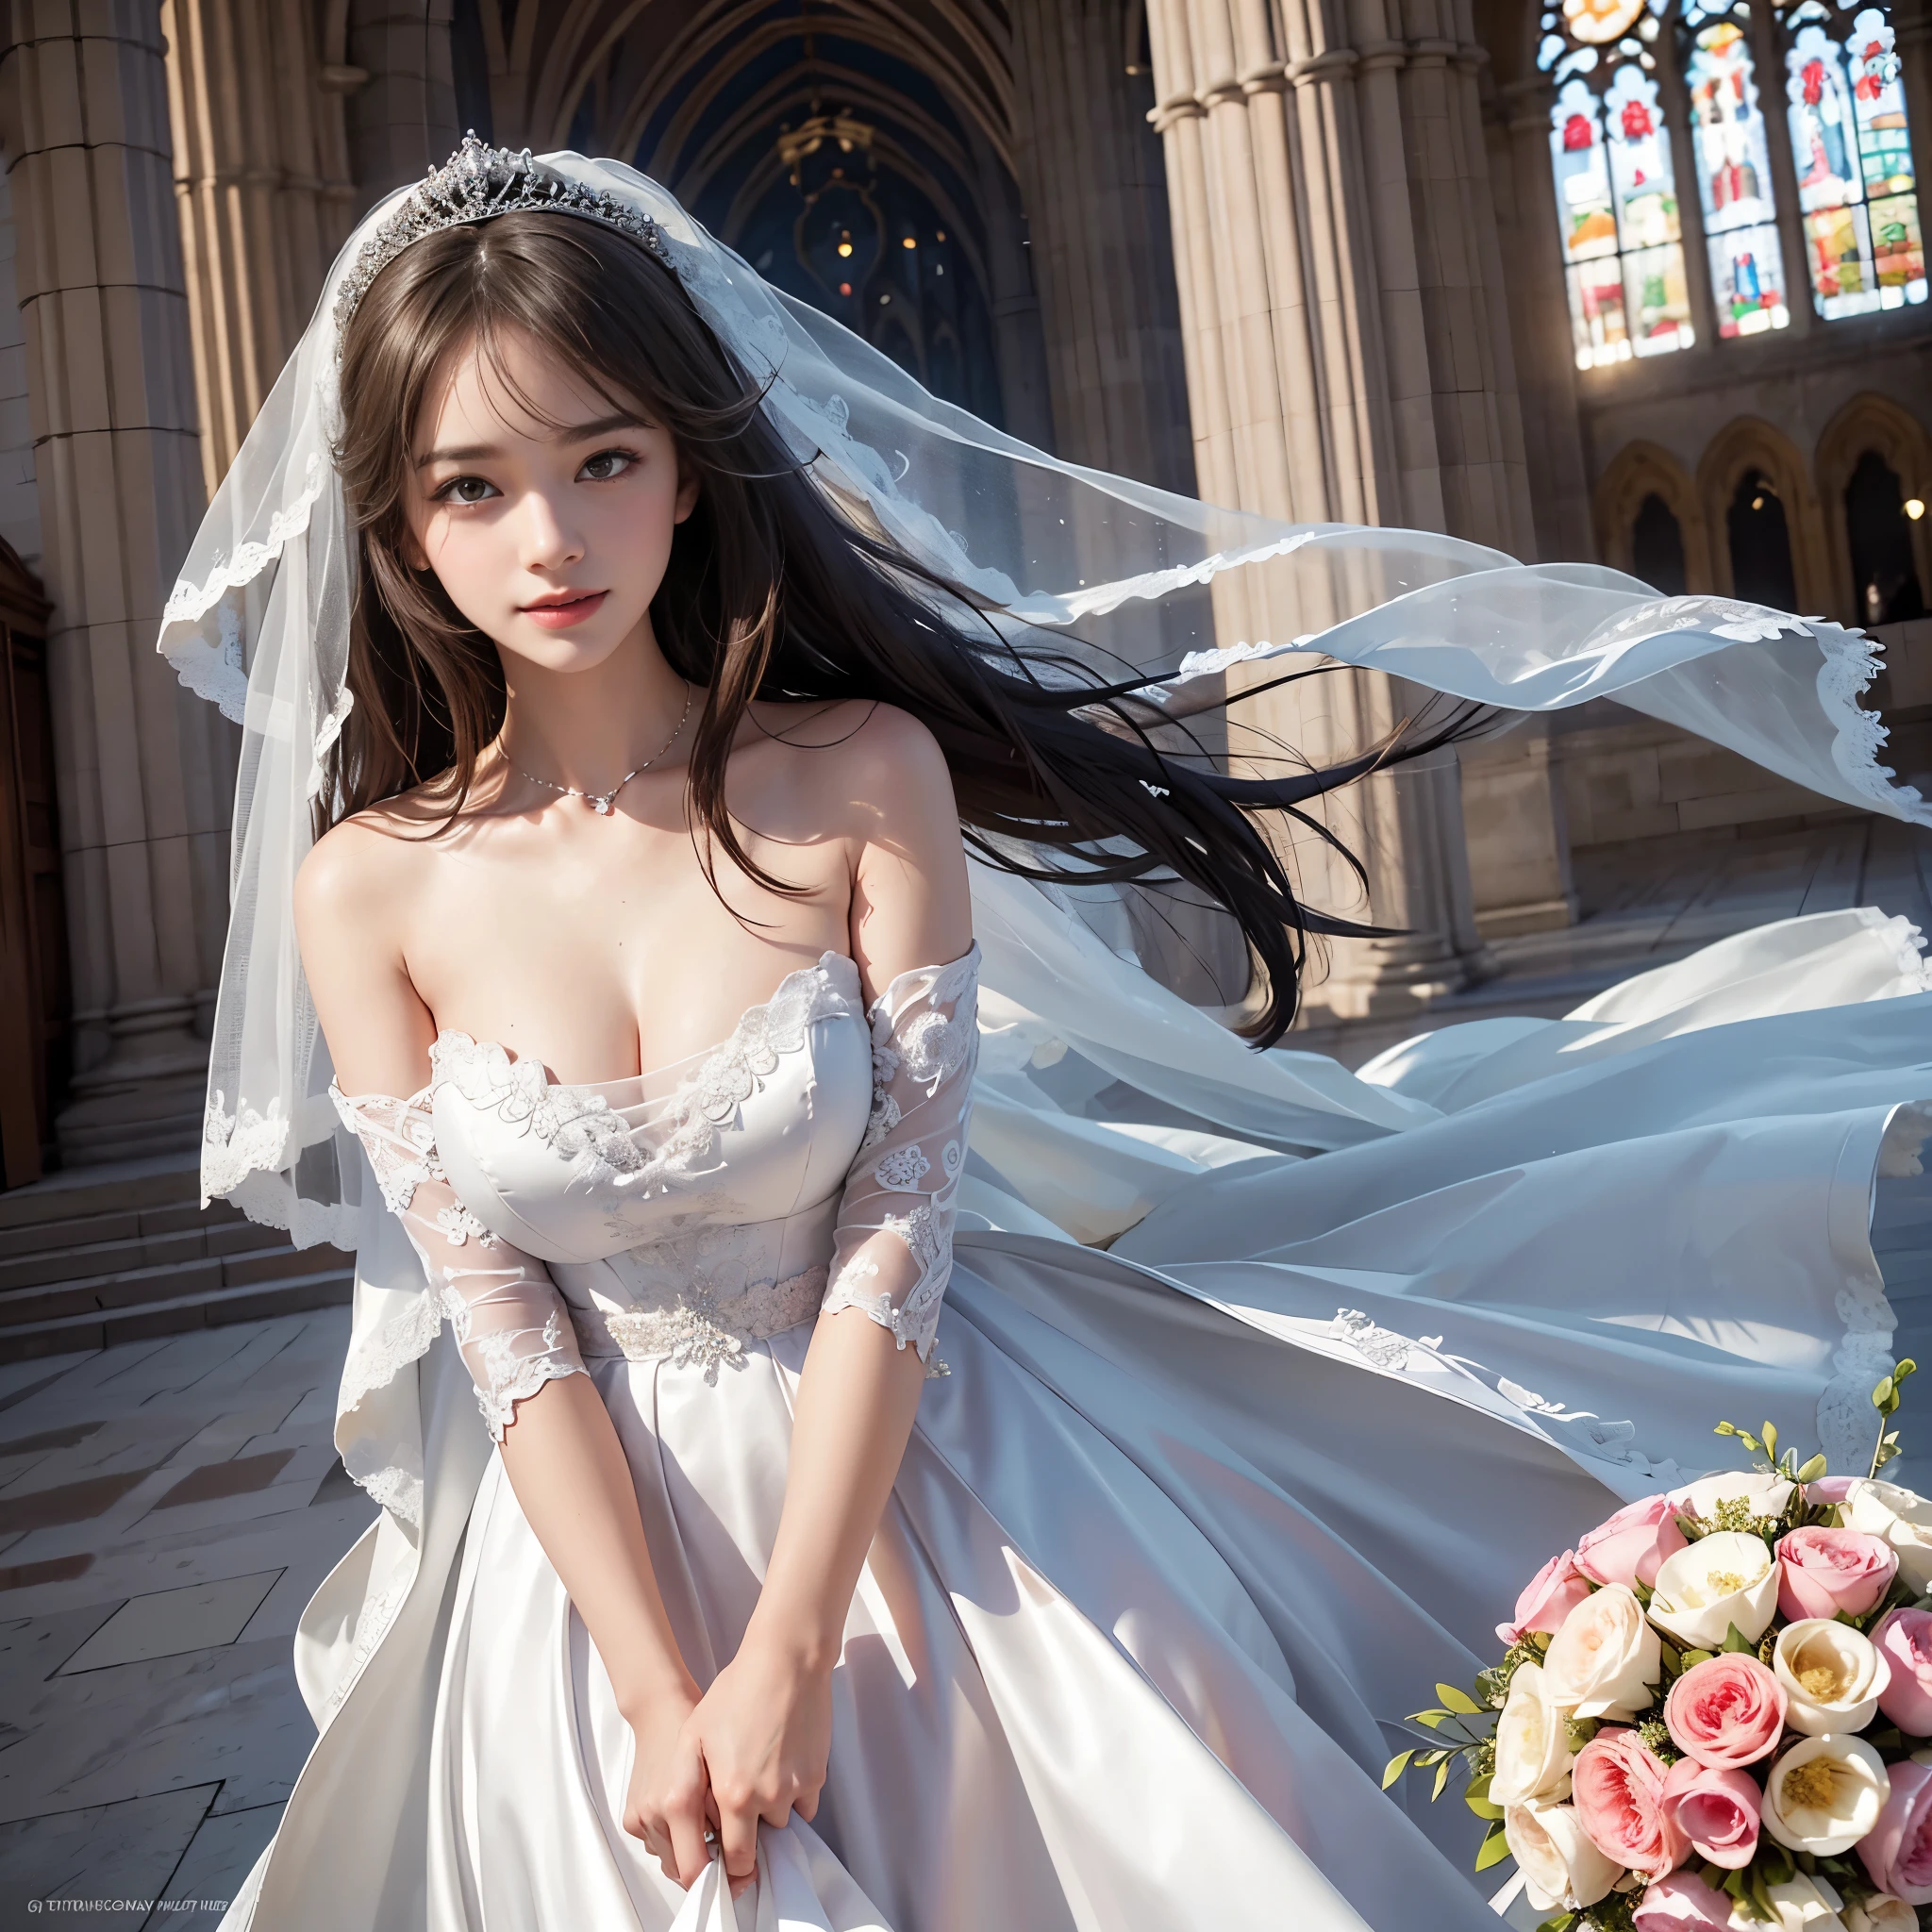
[429,1235,1606,1932]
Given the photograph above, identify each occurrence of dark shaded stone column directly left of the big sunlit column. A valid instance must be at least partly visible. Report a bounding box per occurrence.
[1012,0,1192,491]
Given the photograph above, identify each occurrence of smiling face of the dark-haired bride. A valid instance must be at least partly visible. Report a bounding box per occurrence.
[404,334,697,671]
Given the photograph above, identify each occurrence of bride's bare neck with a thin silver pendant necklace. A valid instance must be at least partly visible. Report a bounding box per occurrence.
[496,618,691,794]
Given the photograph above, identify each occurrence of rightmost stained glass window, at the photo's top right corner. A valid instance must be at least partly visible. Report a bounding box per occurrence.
[1785,0,1926,321]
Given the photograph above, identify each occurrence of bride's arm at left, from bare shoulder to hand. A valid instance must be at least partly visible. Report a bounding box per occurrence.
[295,823,709,1886]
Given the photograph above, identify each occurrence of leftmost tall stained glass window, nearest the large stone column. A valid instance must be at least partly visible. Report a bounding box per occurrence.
[1540,0,1692,369]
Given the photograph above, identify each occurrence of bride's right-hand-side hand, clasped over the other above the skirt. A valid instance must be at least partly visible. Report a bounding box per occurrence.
[684,1633,833,1897]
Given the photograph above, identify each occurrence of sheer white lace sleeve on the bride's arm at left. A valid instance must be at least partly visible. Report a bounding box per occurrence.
[328,1086,583,1441]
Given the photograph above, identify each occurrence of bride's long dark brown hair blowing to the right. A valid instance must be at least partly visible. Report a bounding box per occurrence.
[319,212,1449,1045]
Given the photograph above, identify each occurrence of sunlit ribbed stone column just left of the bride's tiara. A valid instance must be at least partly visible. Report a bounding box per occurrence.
[160,0,356,492]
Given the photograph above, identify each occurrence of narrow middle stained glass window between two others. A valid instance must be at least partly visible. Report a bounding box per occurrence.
[1681,0,1790,336]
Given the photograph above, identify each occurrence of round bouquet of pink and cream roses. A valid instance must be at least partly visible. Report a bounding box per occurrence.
[1383,1362,1932,1932]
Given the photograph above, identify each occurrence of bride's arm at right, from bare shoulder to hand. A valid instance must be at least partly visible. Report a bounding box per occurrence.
[690,711,974,1895]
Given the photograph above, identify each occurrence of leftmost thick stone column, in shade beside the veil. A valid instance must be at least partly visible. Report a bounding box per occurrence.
[0,0,234,1161]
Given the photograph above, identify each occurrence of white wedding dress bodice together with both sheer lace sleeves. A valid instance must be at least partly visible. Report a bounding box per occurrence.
[336,949,979,1440]
